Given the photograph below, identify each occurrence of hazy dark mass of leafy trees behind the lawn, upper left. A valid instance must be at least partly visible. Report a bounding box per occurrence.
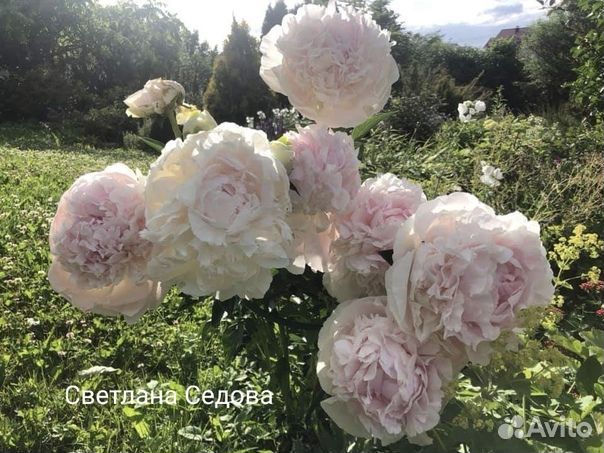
[0,0,214,142]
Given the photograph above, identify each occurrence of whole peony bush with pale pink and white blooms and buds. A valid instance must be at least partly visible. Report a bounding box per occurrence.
[49,1,554,445]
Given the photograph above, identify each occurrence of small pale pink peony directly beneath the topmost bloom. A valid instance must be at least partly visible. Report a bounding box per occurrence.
[287,124,361,214]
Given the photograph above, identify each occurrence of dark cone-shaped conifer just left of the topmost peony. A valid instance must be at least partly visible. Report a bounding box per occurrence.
[203,18,274,124]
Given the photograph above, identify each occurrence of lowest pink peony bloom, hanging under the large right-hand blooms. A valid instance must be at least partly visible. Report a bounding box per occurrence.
[317,297,452,445]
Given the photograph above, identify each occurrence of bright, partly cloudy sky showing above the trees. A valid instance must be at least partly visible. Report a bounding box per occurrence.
[101,0,544,47]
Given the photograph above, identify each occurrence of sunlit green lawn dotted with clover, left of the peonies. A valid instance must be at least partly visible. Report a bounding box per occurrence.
[0,137,280,453]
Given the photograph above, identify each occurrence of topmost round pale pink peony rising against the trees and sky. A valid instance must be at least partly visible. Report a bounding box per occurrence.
[260,0,399,127]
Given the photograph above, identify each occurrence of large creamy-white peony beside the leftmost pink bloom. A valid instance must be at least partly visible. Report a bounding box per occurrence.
[144,123,291,300]
